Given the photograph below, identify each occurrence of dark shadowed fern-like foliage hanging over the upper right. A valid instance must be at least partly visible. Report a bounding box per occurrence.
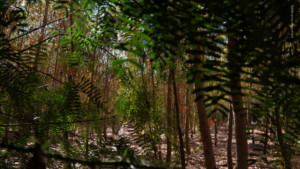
[109,0,300,167]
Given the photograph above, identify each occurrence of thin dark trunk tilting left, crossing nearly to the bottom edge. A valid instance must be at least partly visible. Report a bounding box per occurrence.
[171,66,185,168]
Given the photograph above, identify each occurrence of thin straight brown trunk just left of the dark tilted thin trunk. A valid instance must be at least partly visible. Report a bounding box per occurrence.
[166,66,172,163]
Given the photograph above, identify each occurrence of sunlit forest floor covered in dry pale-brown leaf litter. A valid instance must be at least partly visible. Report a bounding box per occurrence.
[1,125,300,169]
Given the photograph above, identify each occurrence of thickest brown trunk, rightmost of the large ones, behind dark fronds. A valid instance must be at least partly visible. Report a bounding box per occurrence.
[228,35,248,169]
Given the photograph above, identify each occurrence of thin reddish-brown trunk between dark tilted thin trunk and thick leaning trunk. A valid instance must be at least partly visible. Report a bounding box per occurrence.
[185,85,191,155]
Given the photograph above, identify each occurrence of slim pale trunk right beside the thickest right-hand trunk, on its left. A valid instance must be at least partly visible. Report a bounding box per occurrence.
[227,103,233,169]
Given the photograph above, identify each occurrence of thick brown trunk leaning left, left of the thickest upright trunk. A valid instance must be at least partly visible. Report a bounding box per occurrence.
[195,55,216,169]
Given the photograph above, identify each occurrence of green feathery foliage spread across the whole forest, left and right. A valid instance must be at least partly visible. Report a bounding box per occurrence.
[0,0,300,168]
